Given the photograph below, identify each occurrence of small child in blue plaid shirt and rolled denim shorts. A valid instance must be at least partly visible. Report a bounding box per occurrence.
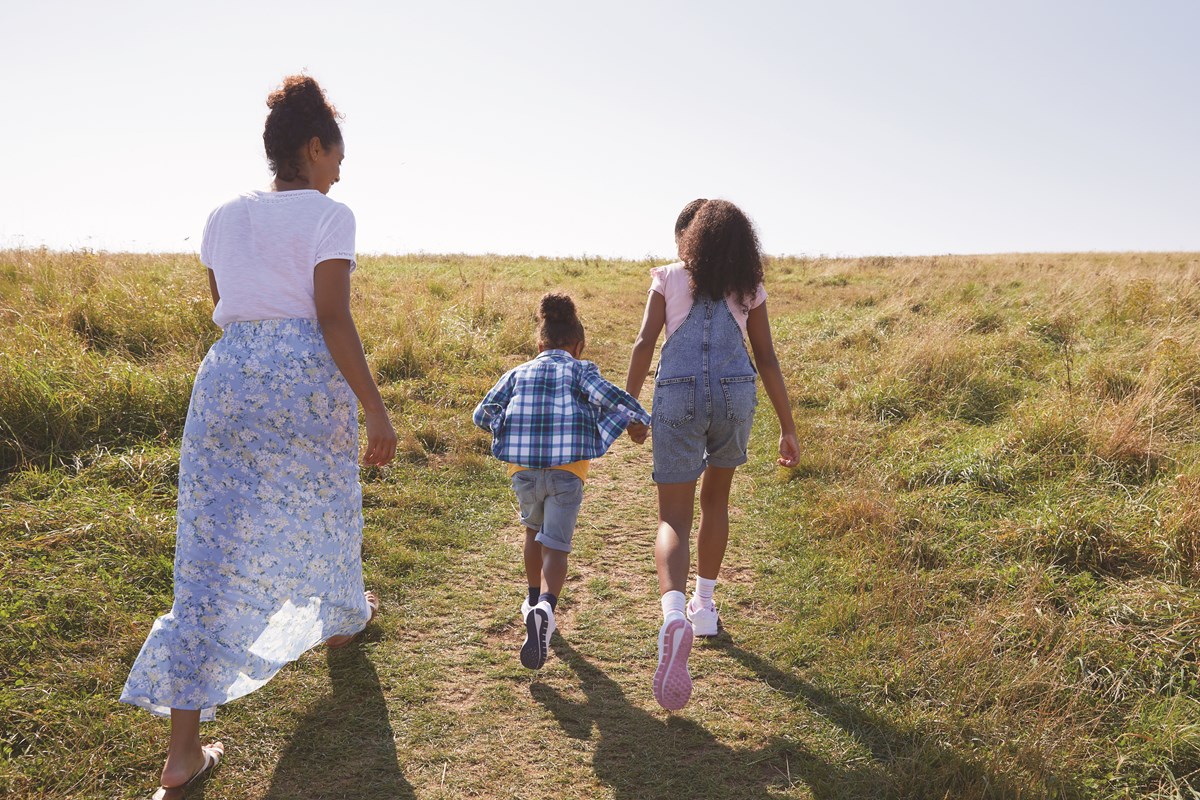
[474,294,650,669]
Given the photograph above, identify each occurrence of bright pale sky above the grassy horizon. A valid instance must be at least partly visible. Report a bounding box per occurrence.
[0,0,1200,258]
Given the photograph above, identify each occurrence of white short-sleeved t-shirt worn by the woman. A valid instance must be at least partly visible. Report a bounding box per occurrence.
[200,190,356,327]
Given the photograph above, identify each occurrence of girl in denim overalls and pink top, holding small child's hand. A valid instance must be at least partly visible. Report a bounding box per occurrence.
[625,199,799,711]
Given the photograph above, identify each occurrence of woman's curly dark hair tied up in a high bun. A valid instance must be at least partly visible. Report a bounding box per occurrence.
[263,76,342,181]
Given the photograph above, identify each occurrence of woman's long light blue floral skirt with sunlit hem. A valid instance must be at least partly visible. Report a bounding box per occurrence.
[121,319,370,720]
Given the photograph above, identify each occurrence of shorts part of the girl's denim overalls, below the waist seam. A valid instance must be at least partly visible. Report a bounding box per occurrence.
[650,374,758,483]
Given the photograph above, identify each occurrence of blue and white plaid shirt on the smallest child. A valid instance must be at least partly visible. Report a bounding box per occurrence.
[473,350,650,469]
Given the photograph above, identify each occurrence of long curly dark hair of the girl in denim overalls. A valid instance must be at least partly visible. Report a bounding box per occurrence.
[676,200,762,305]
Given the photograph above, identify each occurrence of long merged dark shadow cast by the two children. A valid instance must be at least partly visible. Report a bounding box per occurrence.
[529,636,1082,800]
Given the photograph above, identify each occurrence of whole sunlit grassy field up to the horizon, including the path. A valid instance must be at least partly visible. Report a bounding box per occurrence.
[0,251,1200,800]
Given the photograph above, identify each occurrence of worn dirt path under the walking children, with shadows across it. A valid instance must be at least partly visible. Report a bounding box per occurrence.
[231,439,815,800]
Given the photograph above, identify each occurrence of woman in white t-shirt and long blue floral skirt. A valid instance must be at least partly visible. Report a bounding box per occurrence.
[121,76,396,798]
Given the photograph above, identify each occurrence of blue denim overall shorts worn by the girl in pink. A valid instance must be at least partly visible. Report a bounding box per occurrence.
[650,297,758,483]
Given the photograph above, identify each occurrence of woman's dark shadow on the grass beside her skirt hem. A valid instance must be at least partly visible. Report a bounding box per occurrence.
[265,645,416,800]
